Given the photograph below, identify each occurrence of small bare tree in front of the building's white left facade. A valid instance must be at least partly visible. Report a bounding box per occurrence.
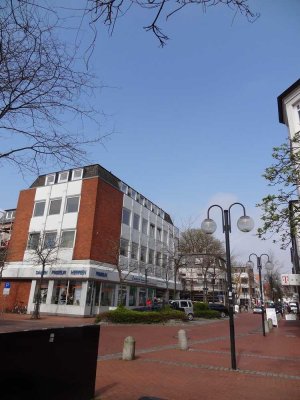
[28,232,59,319]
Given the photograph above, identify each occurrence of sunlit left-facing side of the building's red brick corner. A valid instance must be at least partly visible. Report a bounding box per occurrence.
[73,178,98,260]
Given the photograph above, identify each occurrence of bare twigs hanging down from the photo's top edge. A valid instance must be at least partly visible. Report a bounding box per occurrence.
[86,0,259,46]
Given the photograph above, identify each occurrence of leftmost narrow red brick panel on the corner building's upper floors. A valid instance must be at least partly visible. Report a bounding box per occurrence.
[6,189,36,261]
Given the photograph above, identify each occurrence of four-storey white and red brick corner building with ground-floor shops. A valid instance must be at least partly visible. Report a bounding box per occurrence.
[0,165,179,316]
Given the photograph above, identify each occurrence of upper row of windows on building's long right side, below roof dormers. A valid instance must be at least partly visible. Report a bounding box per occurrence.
[122,207,173,243]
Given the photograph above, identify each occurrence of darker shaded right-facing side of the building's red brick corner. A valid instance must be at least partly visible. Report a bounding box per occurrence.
[91,181,123,264]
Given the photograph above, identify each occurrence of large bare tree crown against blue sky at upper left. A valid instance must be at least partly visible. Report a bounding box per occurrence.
[0,0,105,173]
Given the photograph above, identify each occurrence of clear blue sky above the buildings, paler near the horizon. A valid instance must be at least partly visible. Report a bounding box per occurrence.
[0,0,300,272]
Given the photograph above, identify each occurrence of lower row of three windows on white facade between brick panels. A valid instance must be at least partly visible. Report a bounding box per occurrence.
[27,230,75,250]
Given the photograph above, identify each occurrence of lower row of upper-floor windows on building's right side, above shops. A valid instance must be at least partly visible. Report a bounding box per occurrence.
[120,238,168,266]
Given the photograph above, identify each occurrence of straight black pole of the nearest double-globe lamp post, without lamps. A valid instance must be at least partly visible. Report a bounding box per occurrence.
[224,210,236,369]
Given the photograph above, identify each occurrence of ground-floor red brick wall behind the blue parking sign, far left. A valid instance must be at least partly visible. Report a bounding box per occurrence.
[0,279,31,311]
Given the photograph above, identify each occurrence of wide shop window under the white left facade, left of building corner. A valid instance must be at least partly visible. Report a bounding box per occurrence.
[51,280,82,306]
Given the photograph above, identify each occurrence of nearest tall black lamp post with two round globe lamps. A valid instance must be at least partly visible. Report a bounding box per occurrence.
[201,203,254,370]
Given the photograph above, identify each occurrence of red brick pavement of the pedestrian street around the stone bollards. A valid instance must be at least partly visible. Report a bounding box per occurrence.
[0,313,300,400]
